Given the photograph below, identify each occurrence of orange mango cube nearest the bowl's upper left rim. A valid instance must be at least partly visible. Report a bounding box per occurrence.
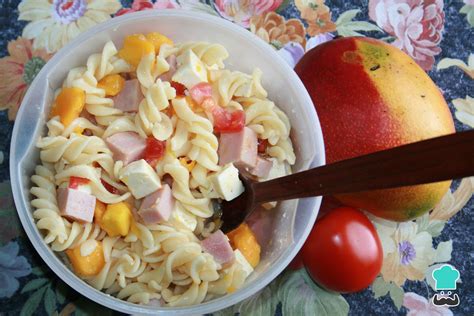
[51,87,86,127]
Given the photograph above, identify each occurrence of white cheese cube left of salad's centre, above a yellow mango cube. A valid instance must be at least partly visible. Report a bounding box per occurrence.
[120,159,161,199]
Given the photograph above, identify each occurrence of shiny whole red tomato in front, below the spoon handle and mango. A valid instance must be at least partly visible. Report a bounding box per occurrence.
[301,207,383,293]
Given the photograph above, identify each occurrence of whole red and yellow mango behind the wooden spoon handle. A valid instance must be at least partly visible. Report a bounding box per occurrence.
[295,37,455,221]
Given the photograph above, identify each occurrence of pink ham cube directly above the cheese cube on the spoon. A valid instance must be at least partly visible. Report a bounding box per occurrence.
[219,127,257,169]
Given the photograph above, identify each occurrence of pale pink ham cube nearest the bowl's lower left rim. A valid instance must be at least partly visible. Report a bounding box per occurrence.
[57,188,96,223]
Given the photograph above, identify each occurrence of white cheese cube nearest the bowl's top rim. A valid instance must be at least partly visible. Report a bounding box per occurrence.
[172,50,207,89]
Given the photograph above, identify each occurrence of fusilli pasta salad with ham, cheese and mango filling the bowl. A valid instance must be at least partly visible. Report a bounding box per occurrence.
[31,33,295,306]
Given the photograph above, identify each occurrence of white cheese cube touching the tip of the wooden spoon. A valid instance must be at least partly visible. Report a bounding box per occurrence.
[209,163,245,201]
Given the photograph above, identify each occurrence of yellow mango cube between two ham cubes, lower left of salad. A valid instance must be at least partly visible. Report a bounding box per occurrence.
[100,202,132,237]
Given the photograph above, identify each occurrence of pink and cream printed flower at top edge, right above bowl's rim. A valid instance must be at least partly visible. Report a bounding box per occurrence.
[214,0,283,27]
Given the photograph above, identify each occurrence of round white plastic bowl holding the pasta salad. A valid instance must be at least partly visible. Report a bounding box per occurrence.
[10,10,325,314]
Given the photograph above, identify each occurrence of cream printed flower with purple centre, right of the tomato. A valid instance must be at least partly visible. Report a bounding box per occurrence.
[372,219,436,286]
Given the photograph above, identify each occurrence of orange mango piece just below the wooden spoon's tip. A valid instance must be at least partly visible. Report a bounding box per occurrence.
[227,223,260,268]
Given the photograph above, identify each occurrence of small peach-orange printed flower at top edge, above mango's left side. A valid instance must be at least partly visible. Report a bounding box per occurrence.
[295,0,336,36]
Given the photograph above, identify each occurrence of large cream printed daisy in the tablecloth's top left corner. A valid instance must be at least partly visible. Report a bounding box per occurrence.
[18,0,121,53]
